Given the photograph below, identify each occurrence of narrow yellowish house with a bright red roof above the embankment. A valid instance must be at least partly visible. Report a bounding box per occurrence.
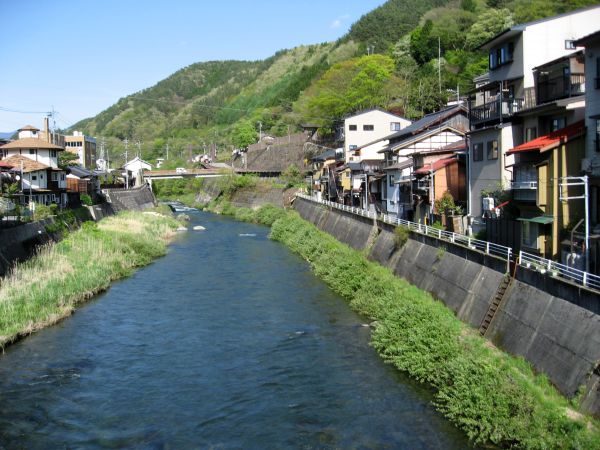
[507,120,585,260]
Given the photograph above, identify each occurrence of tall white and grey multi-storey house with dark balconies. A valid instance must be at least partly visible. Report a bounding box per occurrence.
[468,6,600,230]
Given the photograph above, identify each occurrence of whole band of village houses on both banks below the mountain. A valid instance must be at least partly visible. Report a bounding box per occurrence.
[0,6,600,284]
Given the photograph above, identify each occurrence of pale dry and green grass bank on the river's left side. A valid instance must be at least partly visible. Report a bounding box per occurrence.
[0,212,177,347]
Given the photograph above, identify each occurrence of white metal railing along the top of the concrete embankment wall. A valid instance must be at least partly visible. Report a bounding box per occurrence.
[297,193,600,291]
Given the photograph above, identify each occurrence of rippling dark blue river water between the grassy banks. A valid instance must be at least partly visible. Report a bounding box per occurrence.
[0,212,469,449]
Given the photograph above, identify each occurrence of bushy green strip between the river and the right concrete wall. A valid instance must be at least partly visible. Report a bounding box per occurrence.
[271,213,600,449]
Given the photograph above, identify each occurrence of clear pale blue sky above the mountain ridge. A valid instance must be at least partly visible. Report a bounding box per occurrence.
[0,0,385,132]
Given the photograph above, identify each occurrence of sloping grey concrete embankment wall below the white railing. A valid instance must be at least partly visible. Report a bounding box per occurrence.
[294,198,600,417]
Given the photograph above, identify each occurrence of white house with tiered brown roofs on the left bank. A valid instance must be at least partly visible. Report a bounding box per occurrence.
[0,125,68,206]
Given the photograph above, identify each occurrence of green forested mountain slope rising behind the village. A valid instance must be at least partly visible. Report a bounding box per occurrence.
[72,0,596,166]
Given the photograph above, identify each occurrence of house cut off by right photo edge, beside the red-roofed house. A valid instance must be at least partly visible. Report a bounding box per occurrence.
[575,30,600,236]
